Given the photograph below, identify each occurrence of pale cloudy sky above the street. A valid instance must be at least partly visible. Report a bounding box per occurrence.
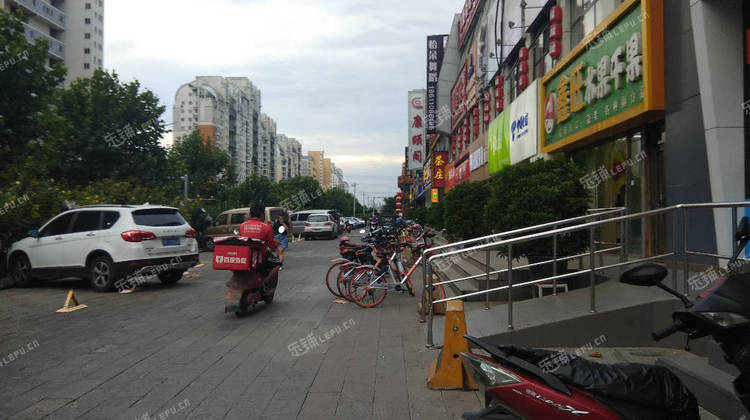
[104,0,464,208]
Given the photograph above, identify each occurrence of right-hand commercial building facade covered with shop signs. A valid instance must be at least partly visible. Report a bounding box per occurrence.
[426,0,750,255]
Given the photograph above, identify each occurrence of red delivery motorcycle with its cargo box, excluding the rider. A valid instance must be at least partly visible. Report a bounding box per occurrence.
[213,226,285,317]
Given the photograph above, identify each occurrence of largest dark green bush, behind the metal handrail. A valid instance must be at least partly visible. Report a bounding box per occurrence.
[485,155,589,257]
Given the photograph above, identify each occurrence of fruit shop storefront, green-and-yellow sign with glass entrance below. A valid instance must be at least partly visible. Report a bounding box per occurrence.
[539,0,665,254]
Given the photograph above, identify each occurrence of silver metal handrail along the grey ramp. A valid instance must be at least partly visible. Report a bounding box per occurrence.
[423,201,750,346]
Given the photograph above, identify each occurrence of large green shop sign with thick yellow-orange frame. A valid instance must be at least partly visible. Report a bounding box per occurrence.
[540,0,664,152]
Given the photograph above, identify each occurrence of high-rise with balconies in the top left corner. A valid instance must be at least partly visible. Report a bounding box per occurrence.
[0,0,104,86]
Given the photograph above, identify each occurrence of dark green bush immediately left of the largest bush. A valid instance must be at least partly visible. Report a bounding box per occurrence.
[444,182,490,239]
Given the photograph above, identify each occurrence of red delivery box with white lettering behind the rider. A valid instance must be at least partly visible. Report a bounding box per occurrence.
[213,236,266,271]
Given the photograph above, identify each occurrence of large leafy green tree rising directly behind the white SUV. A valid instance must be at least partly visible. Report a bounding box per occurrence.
[47,69,170,186]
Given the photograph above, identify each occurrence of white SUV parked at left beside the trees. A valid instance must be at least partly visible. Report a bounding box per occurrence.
[8,205,198,292]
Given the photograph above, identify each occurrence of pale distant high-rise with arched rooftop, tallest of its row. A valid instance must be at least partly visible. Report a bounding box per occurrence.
[173,76,262,181]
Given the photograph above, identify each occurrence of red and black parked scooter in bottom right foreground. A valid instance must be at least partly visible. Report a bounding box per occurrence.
[461,217,750,420]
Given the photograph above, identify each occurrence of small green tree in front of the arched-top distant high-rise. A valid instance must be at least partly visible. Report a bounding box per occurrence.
[167,129,233,197]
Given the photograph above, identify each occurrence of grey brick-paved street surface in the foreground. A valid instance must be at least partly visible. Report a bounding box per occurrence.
[0,233,481,420]
